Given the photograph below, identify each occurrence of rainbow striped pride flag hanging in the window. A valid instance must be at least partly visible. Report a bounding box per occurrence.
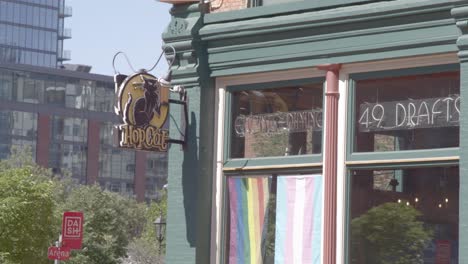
[228,177,271,264]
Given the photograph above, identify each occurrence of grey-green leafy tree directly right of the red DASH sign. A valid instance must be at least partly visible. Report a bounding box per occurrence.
[60,186,145,264]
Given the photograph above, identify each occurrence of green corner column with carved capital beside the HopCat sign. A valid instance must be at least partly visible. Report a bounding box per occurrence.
[163,4,215,264]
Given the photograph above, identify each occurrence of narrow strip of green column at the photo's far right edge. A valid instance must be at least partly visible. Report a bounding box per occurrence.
[451,5,468,263]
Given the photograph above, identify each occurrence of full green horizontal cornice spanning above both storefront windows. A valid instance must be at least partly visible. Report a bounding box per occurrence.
[200,0,461,76]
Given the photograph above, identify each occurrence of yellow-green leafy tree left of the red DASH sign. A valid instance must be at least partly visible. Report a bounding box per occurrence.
[0,164,56,263]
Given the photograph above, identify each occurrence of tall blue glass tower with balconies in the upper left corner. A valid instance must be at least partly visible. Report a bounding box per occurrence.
[0,0,72,68]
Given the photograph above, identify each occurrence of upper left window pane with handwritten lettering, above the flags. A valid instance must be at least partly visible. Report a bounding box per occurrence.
[230,83,323,158]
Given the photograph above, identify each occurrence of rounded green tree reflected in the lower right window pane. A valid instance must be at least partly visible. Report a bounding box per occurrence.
[351,203,432,264]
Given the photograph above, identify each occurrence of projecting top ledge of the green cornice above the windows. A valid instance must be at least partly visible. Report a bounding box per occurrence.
[200,0,460,40]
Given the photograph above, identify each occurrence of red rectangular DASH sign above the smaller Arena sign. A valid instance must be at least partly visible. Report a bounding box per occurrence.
[62,212,84,249]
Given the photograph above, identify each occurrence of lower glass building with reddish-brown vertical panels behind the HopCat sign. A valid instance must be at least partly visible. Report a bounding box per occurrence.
[0,64,167,201]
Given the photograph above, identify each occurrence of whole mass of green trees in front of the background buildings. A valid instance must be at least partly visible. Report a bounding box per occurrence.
[0,150,166,264]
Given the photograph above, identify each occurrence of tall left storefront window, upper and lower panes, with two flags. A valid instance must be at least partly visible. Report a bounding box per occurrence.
[220,75,323,263]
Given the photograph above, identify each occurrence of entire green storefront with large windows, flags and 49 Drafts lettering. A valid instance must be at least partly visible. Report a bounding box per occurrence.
[163,0,468,264]
